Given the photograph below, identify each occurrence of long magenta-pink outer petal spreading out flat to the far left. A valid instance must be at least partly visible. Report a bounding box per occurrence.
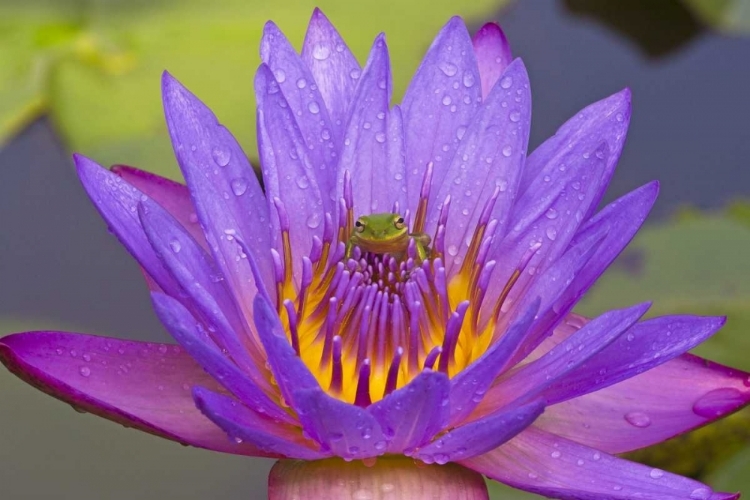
[0,332,269,456]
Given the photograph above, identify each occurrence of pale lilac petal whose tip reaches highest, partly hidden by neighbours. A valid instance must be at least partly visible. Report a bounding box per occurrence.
[302,8,361,138]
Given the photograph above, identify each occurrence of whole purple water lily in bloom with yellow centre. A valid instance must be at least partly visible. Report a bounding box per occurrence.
[0,10,750,500]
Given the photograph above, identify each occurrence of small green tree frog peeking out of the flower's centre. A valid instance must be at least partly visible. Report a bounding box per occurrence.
[345,213,430,261]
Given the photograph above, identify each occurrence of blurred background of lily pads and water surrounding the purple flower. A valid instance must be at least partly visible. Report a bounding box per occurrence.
[0,0,750,500]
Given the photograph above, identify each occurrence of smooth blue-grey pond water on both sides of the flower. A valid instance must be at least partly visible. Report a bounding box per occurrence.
[0,0,750,500]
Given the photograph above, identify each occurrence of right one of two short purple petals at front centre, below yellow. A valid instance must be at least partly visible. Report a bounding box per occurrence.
[367,371,449,453]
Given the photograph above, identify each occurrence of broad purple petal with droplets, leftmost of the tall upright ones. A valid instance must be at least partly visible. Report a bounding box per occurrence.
[162,73,275,317]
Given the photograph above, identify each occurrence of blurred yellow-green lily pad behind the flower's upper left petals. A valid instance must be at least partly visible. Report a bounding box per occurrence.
[0,0,506,177]
